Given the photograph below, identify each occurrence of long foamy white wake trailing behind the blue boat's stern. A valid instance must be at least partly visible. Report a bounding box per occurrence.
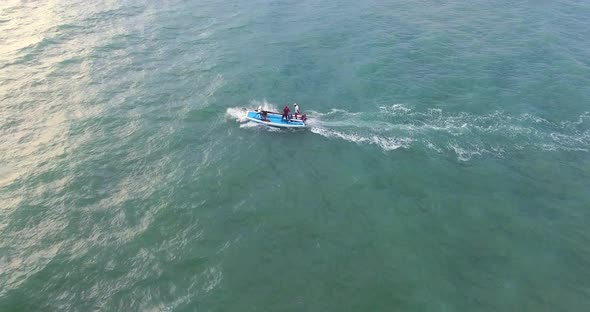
[308,104,590,161]
